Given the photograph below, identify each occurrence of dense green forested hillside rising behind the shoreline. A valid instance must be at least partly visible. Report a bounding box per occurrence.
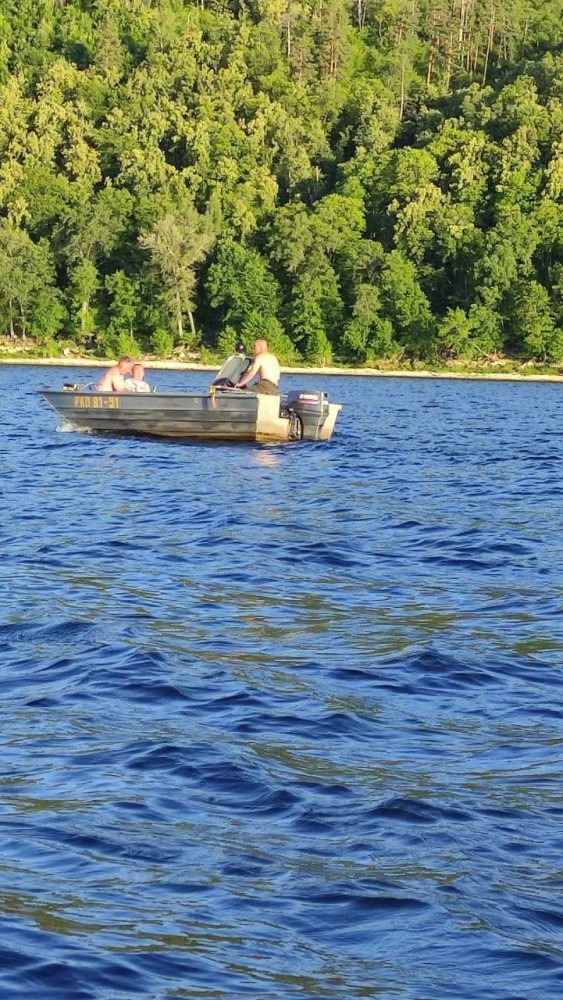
[0,0,563,364]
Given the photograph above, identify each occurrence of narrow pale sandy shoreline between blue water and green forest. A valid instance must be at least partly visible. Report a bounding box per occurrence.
[0,357,563,382]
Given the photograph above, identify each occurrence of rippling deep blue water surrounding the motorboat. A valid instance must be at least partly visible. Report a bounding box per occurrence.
[0,366,563,1000]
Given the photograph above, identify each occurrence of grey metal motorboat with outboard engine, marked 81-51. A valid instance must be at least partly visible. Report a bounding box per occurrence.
[41,355,342,442]
